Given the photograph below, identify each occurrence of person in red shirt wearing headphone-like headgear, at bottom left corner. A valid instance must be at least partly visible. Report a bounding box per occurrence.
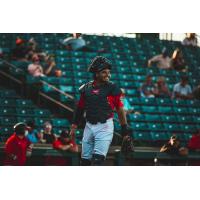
[4,123,32,166]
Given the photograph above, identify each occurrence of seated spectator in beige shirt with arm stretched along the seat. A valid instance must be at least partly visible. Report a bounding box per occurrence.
[148,48,171,69]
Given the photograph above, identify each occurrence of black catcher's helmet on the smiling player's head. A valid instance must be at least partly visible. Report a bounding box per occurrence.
[88,56,112,73]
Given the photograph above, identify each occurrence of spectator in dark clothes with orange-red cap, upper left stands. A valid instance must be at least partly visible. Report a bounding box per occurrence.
[12,38,29,61]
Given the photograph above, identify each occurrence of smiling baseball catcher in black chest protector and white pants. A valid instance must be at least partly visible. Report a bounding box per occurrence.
[71,56,132,165]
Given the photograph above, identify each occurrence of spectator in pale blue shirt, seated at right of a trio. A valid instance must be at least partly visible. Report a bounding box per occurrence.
[172,76,193,99]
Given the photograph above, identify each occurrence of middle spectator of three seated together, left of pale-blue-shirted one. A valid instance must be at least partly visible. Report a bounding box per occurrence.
[154,76,171,98]
